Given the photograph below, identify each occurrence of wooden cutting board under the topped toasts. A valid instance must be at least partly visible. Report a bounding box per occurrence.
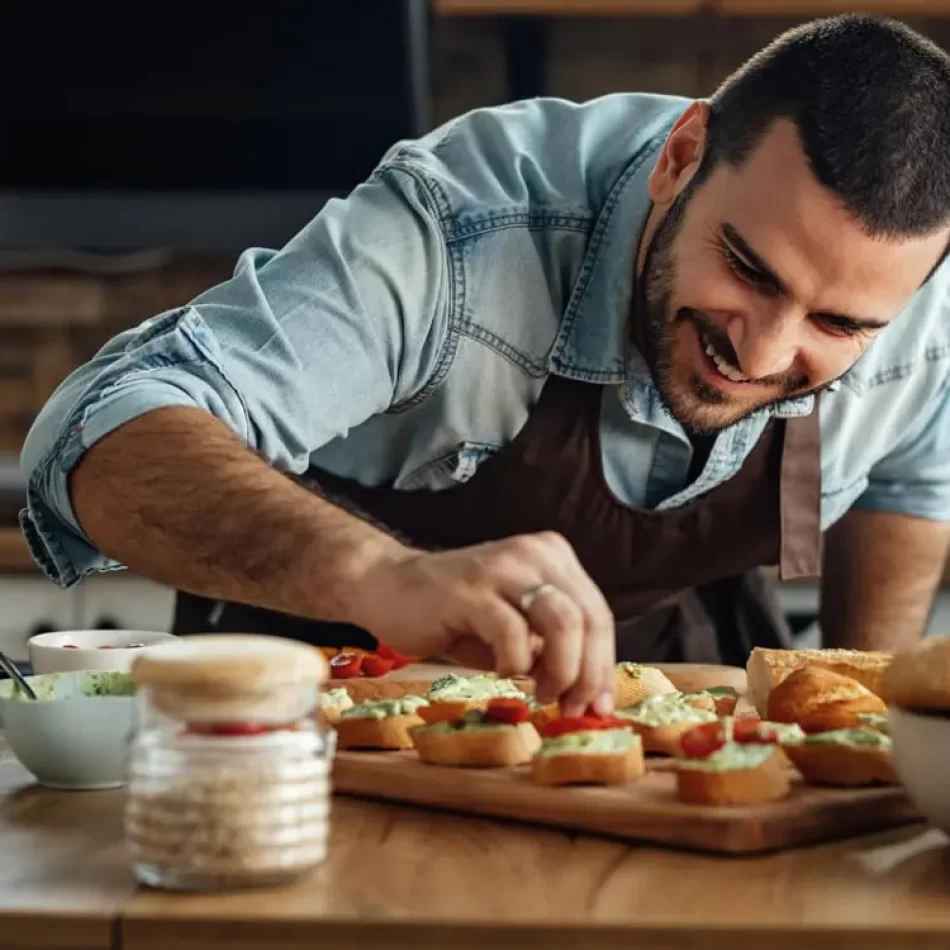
[333,751,921,855]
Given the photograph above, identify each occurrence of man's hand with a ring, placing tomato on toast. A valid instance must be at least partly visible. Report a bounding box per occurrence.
[353,533,615,715]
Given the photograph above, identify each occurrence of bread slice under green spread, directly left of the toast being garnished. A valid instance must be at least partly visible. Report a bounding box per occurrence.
[411,722,541,768]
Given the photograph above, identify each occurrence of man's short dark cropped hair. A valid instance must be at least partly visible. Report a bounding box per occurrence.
[696,14,950,237]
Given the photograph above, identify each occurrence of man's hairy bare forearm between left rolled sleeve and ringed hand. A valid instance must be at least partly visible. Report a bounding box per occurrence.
[70,408,406,623]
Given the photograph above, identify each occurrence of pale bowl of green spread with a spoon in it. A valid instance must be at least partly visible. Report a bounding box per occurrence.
[0,672,135,789]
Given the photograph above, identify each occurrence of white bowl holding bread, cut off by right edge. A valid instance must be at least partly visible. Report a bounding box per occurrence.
[887,706,950,832]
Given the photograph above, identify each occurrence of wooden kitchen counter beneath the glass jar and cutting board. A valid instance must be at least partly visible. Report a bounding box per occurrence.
[0,759,950,950]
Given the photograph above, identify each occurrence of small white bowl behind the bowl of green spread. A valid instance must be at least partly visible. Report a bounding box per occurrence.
[27,630,178,673]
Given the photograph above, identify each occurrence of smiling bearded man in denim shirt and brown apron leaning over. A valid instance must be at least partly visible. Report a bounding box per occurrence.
[16,16,950,714]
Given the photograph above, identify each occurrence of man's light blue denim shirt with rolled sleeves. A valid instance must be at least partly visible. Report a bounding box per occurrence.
[21,94,950,586]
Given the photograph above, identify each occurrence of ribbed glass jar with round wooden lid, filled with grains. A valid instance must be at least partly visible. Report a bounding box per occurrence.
[125,635,336,891]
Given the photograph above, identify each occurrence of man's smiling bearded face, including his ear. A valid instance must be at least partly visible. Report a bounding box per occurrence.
[638,112,950,434]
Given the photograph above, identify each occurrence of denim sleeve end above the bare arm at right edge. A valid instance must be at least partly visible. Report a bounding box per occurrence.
[854,384,950,521]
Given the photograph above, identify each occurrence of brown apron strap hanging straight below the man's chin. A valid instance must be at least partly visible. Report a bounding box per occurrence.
[779,397,822,581]
